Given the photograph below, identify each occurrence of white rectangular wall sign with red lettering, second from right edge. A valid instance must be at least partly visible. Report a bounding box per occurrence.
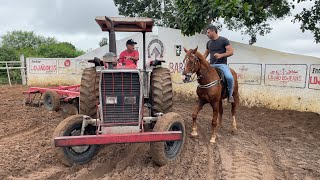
[264,64,307,88]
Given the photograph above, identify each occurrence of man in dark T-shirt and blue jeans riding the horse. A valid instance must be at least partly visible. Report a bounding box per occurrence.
[203,25,234,103]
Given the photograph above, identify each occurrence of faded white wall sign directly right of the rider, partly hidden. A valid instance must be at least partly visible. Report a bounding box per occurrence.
[229,63,262,85]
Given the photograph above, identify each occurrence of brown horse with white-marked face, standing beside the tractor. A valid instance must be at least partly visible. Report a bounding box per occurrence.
[182,46,239,143]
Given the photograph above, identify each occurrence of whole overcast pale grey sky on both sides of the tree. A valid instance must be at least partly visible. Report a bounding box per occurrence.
[0,0,320,57]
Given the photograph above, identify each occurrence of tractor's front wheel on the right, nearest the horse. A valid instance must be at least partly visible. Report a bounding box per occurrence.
[150,112,185,166]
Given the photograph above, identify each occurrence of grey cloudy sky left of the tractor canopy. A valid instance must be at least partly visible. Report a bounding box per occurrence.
[0,0,122,50]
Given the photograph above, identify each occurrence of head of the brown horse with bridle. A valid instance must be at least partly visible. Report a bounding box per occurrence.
[182,46,200,82]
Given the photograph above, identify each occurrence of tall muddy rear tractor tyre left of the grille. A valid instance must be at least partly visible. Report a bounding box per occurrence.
[79,67,100,118]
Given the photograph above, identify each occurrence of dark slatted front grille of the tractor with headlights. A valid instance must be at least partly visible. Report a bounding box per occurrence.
[100,71,140,126]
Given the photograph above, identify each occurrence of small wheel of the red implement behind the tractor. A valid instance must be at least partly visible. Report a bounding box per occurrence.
[43,90,60,111]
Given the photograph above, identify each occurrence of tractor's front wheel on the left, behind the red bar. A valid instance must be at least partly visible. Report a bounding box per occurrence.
[53,115,100,166]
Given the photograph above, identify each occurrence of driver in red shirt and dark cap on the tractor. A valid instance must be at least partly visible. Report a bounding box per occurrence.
[119,39,139,68]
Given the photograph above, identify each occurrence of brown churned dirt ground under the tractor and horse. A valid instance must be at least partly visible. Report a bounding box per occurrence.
[0,86,320,180]
